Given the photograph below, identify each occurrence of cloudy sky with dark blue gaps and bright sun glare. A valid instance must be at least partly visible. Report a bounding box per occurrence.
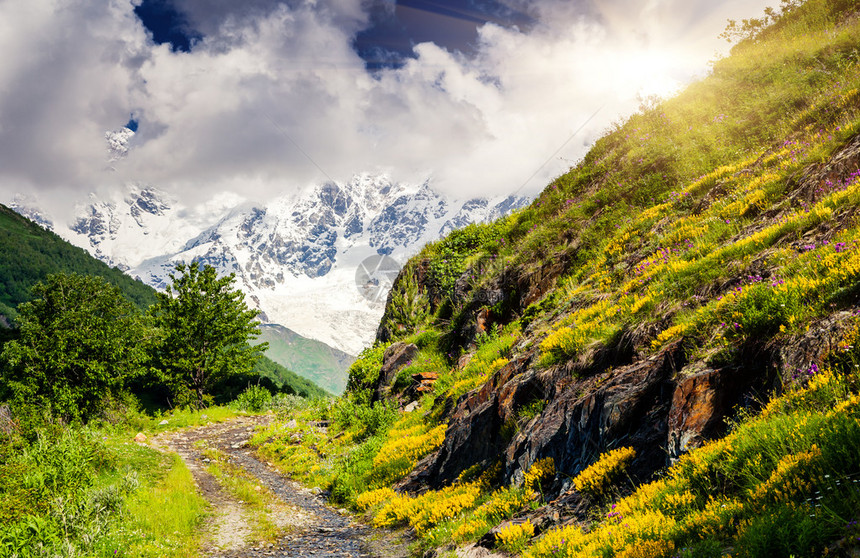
[0,0,775,219]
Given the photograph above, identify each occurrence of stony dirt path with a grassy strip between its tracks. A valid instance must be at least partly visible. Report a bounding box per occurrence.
[153,416,409,558]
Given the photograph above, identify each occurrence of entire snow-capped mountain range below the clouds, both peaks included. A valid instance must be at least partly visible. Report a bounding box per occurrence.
[20,174,527,354]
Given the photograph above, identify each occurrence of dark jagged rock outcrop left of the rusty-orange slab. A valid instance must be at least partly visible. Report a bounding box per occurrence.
[402,344,683,496]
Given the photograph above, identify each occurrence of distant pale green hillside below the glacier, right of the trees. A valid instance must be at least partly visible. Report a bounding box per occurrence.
[258,324,355,394]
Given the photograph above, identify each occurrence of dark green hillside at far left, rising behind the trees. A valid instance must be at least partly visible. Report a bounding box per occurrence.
[0,205,155,321]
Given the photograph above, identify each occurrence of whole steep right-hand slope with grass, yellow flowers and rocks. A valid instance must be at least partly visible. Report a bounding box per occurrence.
[254,0,860,558]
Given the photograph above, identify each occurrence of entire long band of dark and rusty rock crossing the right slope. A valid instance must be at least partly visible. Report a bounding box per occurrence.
[398,312,852,496]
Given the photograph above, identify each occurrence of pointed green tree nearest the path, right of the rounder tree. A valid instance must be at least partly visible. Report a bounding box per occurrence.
[152,262,268,407]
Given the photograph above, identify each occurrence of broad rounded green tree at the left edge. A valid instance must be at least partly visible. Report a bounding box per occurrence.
[0,273,147,420]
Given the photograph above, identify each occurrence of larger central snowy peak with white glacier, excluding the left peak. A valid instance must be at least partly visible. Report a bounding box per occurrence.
[130,174,525,354]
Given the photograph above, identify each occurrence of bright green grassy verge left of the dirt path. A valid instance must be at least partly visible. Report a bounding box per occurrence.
[0,427,206,558]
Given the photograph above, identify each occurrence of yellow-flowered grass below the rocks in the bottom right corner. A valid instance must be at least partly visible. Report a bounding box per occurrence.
[524,354,860,558]
